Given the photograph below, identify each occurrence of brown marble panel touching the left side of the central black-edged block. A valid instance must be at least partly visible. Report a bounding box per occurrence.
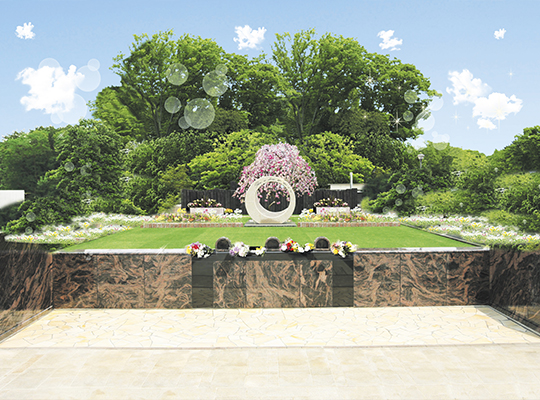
[143,254,192,308]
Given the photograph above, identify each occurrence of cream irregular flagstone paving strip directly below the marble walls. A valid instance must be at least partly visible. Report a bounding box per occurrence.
[0,306,540,348]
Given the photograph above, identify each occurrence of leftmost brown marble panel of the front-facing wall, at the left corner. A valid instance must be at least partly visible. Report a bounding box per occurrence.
[53,253,98,308]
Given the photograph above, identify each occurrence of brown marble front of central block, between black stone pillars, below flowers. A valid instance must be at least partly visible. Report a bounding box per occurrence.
[213,253,333,308]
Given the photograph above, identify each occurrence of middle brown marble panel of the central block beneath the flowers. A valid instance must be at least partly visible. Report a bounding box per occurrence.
[245,259,300,308]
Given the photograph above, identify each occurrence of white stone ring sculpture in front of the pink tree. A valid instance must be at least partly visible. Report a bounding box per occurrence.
[246,176,296,224]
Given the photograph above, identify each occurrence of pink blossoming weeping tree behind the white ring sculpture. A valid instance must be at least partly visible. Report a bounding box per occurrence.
[233,143,317,203]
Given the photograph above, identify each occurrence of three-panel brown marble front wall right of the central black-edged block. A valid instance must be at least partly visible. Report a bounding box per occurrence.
[354,250,489,307]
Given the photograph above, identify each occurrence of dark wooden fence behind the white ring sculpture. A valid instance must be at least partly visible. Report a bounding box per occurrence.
[182,189,362,214]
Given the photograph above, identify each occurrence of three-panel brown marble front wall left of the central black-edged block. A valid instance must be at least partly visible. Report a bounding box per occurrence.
[53,253,191,308]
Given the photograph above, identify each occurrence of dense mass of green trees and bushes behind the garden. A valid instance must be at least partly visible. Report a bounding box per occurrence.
[0,30,540,236]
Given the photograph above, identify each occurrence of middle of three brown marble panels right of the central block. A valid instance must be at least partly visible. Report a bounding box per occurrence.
[401,252,448,307]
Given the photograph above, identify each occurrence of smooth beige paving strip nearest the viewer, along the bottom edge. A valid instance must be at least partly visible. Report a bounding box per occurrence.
[0,344,540,400]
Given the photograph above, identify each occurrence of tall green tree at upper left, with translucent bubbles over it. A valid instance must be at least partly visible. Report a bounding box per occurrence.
[112,30,224,138]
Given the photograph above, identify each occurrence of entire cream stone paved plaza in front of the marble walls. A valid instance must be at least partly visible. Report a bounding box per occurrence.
[0,306,540,400]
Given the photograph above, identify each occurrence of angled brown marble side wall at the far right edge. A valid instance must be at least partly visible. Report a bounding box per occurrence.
[490,250,540,332]
